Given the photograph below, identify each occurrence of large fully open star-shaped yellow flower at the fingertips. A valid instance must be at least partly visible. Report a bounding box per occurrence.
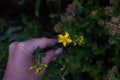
[58,32,72,46]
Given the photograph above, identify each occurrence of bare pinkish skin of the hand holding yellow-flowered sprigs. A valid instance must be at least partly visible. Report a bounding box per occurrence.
[3,38,62,80]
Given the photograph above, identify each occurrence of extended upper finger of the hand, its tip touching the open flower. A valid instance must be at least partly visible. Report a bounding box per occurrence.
[24,38,57,52]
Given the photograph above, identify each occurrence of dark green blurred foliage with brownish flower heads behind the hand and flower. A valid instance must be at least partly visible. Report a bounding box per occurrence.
[0,0,120,80]
